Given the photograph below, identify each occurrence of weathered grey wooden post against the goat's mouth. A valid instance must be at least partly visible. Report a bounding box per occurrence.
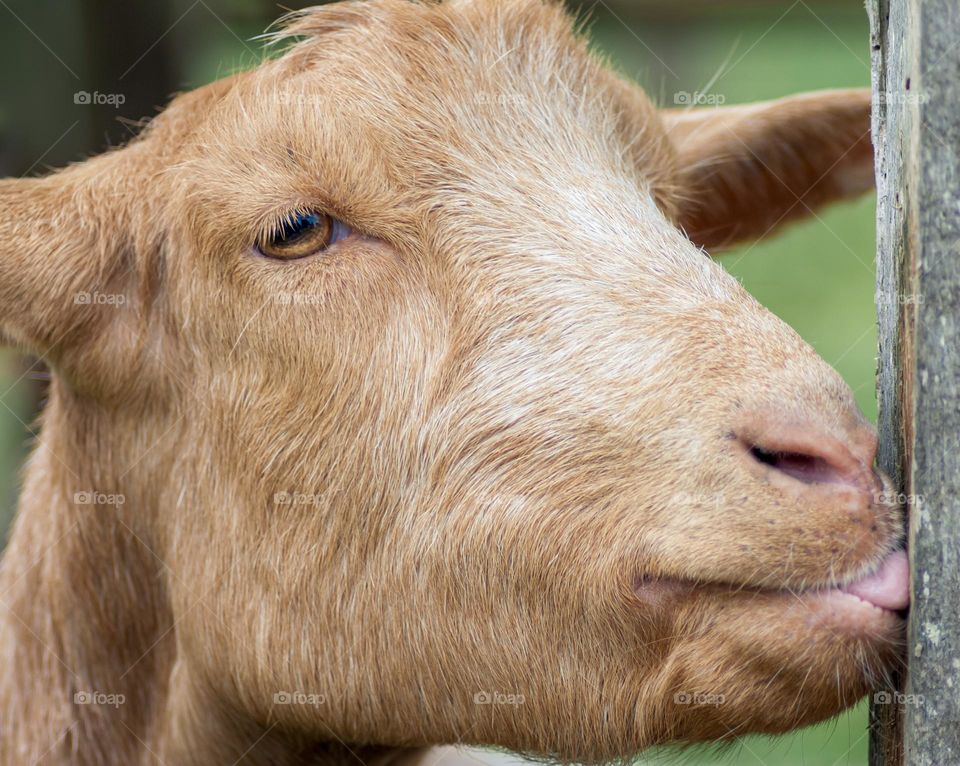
[868,0,960,766]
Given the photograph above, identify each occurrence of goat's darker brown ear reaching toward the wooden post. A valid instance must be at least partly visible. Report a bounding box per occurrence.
[661,90,873,250]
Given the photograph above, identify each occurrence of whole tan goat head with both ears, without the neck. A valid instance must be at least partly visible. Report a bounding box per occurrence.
[3,0,902,761]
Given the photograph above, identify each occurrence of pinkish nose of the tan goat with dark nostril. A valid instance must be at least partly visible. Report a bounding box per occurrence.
[737,417,882,493]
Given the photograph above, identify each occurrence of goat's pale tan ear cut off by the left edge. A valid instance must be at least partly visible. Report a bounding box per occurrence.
[0,160,124,359]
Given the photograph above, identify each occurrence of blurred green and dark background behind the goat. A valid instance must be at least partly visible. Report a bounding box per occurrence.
[0,0,876,766]
